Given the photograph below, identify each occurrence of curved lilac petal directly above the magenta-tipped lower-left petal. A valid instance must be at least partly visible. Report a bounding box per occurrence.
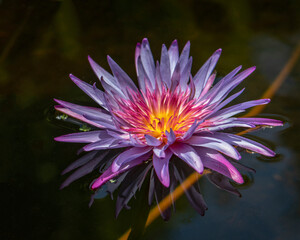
[111,147,153,172]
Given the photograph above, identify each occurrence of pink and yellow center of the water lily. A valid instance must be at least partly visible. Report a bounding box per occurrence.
[113,89,205,141]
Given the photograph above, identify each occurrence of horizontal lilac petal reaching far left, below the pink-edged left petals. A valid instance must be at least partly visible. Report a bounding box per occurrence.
[54,131,109,143]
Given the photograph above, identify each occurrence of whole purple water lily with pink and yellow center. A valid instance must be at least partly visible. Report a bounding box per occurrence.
[55,39,282,218]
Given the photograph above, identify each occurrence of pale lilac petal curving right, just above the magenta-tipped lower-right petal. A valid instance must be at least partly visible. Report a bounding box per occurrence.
[186,136,241,160]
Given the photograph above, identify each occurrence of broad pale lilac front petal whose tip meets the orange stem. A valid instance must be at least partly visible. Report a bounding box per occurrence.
[170,143,203,173]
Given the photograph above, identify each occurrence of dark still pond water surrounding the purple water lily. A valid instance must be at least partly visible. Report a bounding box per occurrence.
[0,0,300,240]
